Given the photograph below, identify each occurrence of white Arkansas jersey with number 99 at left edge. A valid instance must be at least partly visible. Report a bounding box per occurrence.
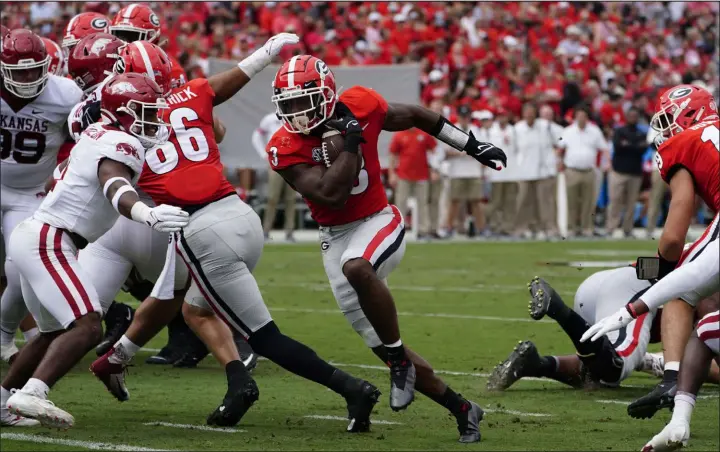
[0,75,83,189]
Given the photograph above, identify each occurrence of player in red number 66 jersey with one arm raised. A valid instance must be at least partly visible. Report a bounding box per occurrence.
[91,33,379,431]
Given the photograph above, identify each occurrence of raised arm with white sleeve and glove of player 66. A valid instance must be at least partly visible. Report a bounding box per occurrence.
[208,33,300,105]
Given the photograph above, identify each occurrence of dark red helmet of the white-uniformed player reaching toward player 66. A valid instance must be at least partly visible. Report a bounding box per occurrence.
[100,73,169,149]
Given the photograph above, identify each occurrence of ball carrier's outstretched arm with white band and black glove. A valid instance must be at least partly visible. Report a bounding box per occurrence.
[383,104,507,171]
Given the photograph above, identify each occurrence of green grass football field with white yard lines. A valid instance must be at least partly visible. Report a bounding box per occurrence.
[2,241,720,451]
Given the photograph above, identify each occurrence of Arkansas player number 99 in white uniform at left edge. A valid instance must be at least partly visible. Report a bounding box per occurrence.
[0,29,82,368]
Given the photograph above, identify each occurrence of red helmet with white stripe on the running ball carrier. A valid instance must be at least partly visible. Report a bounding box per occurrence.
[272,55,337,134]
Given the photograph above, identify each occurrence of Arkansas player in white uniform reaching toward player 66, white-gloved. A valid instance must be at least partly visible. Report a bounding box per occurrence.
[2,74,188,428]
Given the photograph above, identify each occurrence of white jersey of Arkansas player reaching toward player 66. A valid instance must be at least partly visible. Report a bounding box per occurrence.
[33,123,145,242]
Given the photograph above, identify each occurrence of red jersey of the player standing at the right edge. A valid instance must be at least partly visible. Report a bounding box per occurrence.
[655,120,720,212]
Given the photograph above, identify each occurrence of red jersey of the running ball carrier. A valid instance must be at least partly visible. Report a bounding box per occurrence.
[266,86,388,226]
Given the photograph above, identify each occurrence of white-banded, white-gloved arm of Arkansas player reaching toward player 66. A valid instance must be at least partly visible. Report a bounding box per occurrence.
[98,159,188,232]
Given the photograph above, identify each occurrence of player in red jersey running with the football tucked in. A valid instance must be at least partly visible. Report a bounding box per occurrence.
[266,55,506,442]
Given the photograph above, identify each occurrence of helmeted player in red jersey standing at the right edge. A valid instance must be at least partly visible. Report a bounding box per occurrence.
[584,85,720,418]
